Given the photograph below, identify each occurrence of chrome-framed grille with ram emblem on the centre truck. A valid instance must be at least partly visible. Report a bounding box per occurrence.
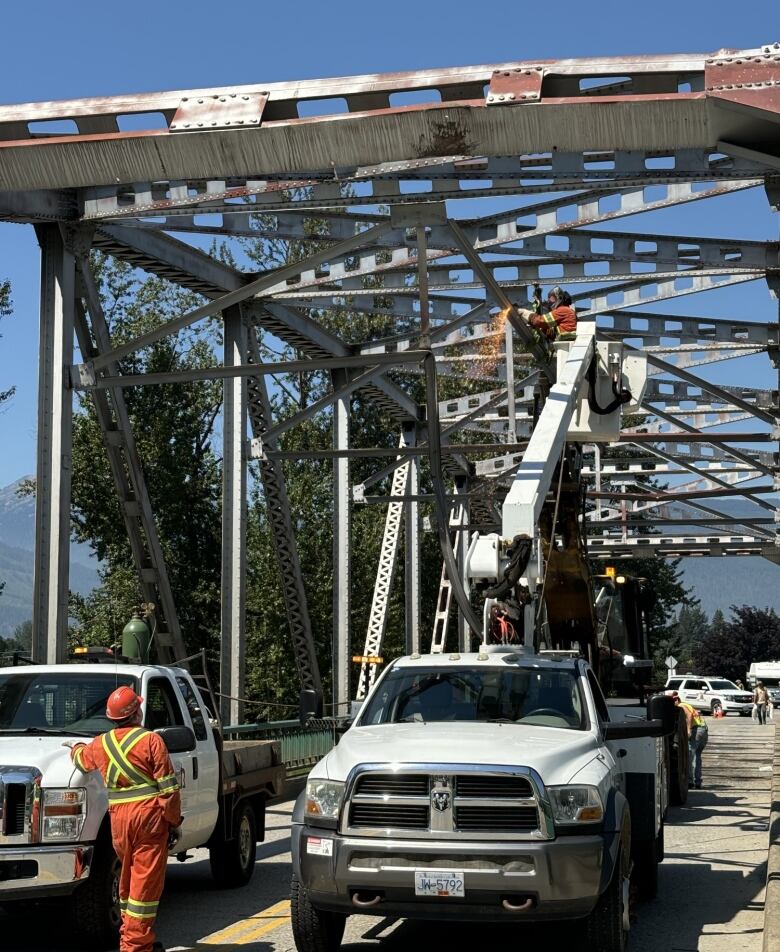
[342,767,549,839]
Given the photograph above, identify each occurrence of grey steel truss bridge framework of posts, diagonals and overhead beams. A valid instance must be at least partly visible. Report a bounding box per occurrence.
[0,43,780,723]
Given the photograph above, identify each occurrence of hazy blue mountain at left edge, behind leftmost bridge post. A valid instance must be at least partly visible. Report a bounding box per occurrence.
[0,480,99,637]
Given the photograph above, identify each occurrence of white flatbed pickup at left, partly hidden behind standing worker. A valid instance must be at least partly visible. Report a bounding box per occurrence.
[0,664,284,948]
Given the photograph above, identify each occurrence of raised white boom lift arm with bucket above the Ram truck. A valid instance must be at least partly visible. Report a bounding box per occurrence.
[465,321,646,669]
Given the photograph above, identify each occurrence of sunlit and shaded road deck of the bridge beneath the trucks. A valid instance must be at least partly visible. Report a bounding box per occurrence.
[0,717,780,952]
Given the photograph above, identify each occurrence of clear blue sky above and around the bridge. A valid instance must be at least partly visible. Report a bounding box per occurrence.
[0,0,780,486]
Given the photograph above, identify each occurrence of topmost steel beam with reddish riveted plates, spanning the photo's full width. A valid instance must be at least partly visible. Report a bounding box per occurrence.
[0,46,780,191]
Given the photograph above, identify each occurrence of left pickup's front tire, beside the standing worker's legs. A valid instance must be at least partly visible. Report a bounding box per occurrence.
[68,840,122,950]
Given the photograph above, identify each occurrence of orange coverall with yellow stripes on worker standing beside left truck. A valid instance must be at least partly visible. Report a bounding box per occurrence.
[71,727,181,952]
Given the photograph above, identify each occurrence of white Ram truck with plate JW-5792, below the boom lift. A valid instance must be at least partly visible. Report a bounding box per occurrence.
[292,647,676,952]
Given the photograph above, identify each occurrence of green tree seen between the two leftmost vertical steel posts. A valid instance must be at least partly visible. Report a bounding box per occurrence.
[71,256,221,652]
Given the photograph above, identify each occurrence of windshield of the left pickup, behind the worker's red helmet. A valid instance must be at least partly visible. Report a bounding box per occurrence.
[0,669,138,735]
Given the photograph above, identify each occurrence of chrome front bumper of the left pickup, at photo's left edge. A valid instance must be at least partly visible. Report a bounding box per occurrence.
[0,845,93,902]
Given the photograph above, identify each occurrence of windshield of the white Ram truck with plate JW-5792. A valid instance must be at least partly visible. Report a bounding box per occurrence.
[360,667,587,730]
